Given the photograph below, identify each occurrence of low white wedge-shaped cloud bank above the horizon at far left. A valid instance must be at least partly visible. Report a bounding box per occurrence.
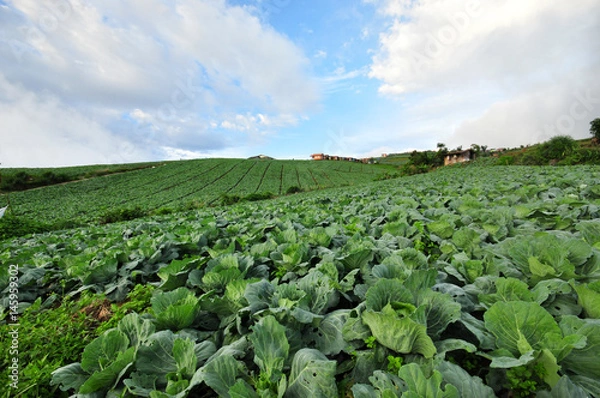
[0,74,149,167]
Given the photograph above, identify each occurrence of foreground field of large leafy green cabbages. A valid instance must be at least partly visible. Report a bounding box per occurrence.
[0,166,600,398]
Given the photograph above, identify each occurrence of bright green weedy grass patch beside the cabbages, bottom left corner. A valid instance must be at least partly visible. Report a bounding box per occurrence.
[0,285,154,398]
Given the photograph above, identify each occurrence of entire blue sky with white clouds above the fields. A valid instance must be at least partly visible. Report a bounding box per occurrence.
[0,0,600,167]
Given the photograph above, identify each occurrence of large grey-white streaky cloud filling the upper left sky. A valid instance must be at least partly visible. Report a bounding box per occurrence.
[0,0,320,164]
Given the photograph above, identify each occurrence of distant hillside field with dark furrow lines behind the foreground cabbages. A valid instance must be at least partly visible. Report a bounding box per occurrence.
[0,159,387,227]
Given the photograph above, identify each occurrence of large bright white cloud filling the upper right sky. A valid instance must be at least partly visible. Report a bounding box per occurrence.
[367,0,600,146]
